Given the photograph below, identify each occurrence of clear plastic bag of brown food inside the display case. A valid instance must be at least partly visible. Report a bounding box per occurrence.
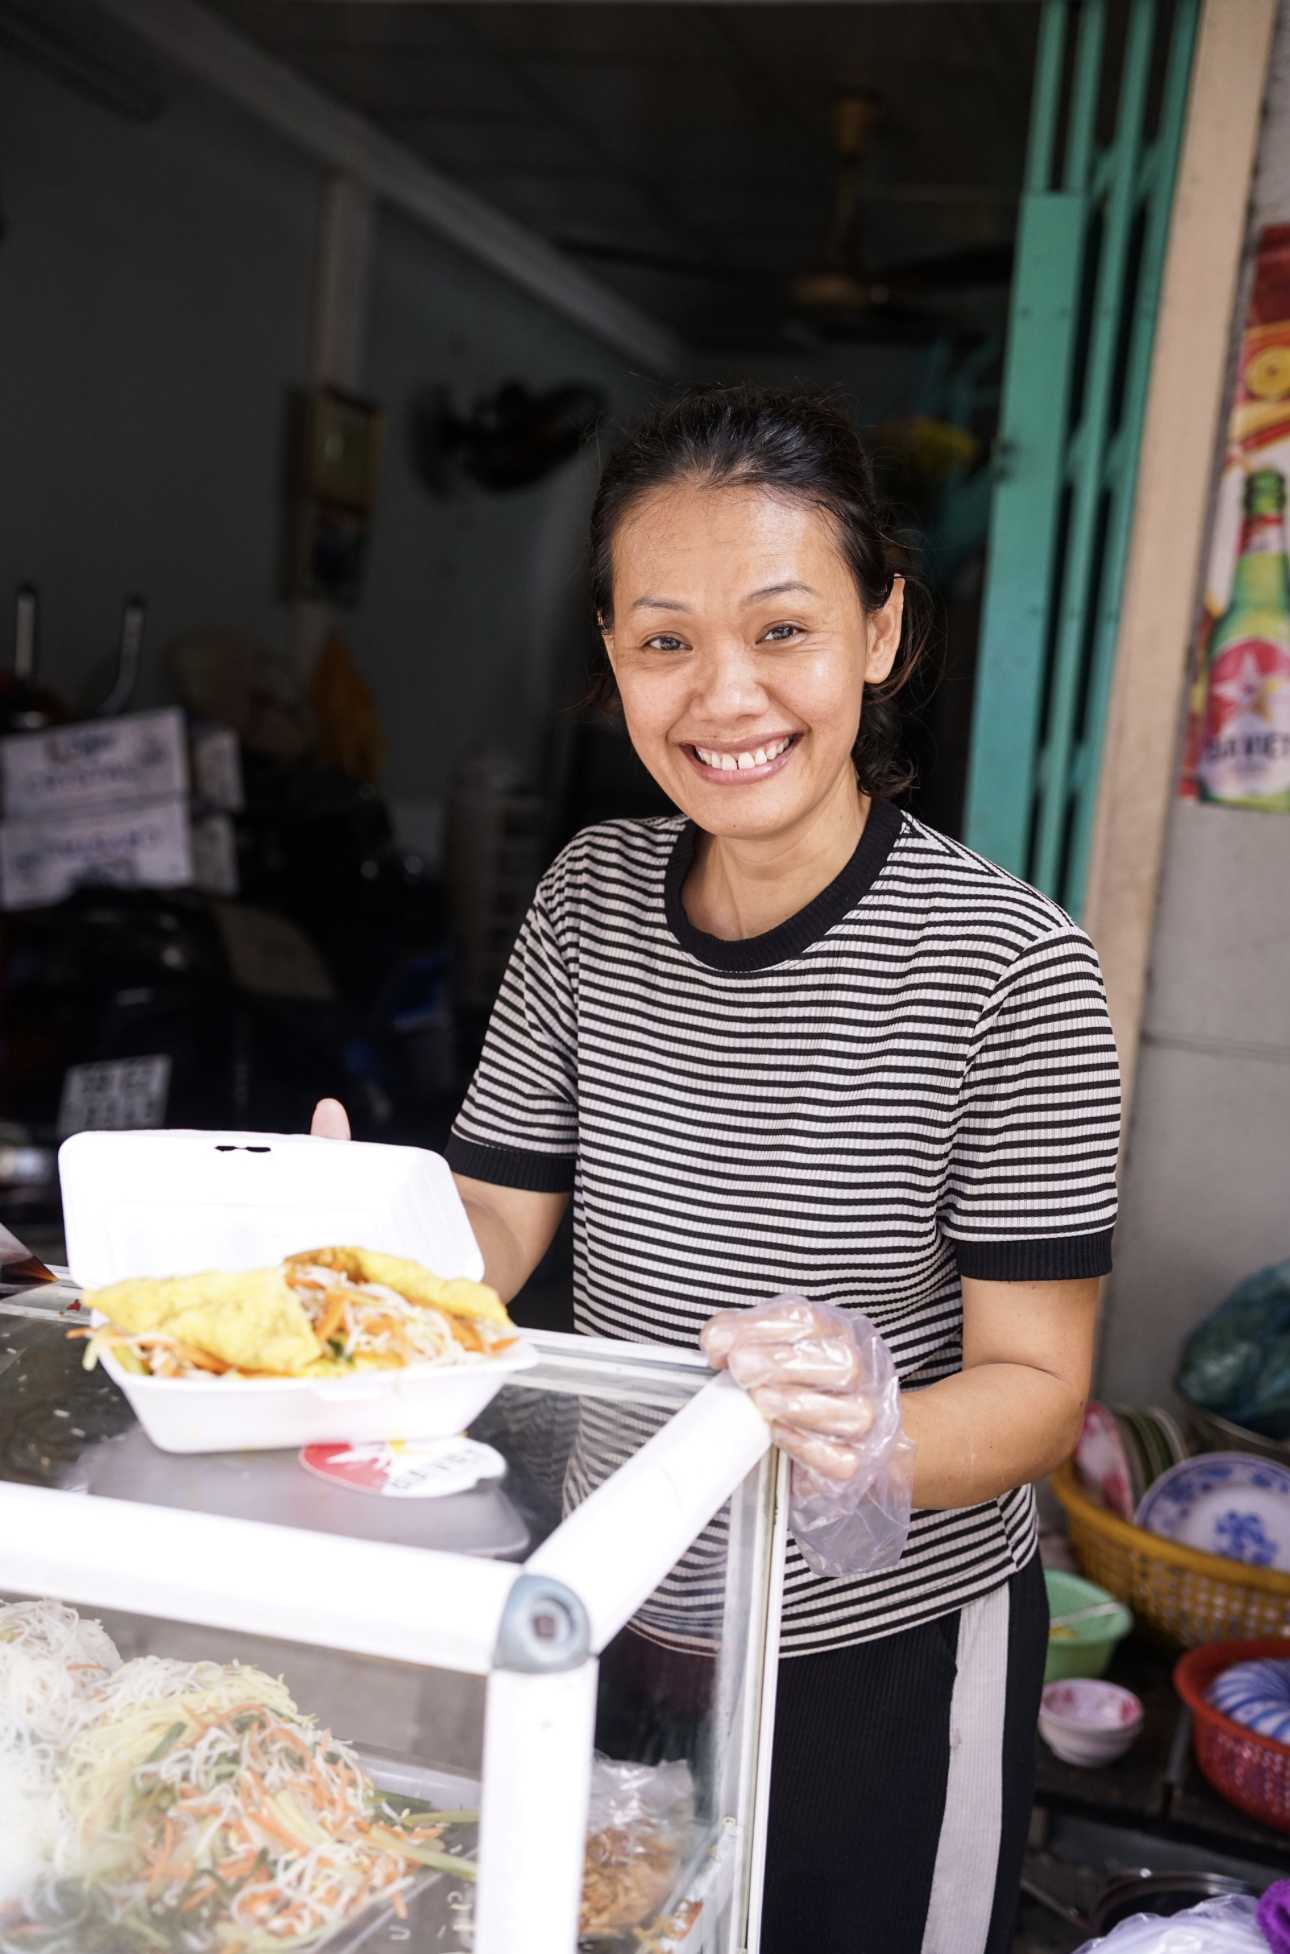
[579,1755,696,1938]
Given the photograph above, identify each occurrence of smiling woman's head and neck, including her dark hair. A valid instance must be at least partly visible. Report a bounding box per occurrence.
[590,389,923,940]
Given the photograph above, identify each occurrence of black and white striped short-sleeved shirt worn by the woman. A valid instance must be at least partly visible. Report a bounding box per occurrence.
[448,803,1120,1655]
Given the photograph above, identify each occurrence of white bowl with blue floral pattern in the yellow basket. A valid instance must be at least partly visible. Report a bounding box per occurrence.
[1136,1452,1290,1569]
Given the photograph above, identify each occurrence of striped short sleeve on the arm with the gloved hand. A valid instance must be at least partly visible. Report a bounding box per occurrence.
[940,924,1120,1282]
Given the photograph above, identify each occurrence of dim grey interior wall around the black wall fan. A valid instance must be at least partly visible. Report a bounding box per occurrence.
[0,53,647,803]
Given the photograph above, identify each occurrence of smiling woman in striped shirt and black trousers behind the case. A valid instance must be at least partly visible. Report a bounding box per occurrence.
[320,387,1118,1954]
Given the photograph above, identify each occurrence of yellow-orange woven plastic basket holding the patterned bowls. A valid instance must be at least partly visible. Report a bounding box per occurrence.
[1052,1460,1290,1655]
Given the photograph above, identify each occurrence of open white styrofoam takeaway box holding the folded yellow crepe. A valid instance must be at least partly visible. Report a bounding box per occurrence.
[59,1129,519,1452]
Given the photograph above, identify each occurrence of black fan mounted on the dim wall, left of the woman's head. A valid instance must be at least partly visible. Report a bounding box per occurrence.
[410,379,604,494]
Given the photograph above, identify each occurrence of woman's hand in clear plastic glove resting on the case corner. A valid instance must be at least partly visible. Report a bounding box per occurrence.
[700,1296,874,1479]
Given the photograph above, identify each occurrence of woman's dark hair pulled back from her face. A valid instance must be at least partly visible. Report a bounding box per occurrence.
[590,385,926,799]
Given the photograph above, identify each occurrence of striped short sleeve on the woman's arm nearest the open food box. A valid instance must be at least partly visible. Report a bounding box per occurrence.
[446,883,579,1194]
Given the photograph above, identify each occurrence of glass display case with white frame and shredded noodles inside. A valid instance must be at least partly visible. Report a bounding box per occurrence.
[0,1288,786,1954]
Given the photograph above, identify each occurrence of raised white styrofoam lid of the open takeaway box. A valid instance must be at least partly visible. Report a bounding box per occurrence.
[59,1129,483,1290]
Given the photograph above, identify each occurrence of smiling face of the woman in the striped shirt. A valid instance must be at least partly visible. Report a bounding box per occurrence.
[604,485,903,836]
